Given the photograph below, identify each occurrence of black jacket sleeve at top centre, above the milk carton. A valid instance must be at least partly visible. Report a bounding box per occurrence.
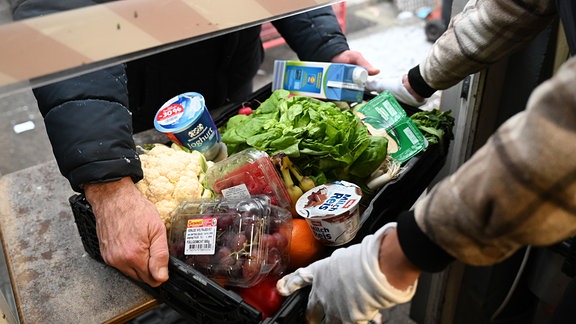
[272,6,350,62]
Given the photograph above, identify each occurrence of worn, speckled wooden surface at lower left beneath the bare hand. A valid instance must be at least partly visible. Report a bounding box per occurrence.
[0,161,156,324]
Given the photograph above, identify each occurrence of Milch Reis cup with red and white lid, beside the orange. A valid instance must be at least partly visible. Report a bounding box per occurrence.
[296,181,362,246]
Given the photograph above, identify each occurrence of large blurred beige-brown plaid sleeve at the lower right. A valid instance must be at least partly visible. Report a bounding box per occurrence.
[415,58,576,265]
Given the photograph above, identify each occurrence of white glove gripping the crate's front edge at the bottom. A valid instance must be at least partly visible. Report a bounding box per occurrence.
[276,223,416,323]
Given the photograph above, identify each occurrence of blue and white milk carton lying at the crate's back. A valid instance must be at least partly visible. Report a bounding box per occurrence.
[272,60,368,102]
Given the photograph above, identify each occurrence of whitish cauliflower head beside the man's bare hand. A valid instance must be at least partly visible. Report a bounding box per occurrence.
[136,144,213,228]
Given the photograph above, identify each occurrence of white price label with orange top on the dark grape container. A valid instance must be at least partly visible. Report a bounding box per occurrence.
[184,217,218,255]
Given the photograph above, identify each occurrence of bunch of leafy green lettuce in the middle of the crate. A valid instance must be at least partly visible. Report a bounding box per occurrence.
[220,90,388,182]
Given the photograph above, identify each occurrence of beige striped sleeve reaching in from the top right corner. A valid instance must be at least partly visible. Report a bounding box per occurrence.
[420,0,557,90]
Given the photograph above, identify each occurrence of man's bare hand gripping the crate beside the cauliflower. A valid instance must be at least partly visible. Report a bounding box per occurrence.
[84,178,169,287]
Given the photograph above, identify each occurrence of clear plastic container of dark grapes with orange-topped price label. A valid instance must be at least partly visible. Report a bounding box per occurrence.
[169,195,292,287]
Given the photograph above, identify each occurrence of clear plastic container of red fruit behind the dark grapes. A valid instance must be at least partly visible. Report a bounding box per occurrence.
[206,148,291,209]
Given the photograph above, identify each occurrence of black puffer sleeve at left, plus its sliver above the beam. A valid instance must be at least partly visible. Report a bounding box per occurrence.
[13,0,143,191]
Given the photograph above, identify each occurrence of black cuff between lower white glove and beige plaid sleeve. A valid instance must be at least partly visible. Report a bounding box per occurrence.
[396,211,454,272]
